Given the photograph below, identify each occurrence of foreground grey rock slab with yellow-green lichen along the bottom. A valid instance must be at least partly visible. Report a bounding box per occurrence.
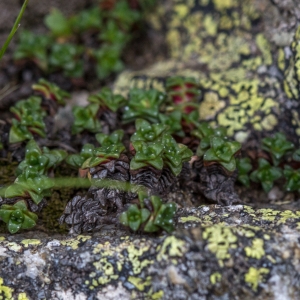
[0,205,300,300]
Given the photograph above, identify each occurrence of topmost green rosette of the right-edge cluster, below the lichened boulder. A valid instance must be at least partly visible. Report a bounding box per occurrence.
[262,132,295,166]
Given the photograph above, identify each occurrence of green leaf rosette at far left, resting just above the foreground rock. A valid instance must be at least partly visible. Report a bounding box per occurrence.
[0,200,38,234]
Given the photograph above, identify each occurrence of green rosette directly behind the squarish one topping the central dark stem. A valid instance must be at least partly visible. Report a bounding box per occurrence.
[130,119,167,143]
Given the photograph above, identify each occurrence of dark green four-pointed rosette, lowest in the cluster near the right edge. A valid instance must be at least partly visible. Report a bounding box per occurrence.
[250,158,282,193]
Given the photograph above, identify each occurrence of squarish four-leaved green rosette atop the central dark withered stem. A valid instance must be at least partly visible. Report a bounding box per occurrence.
[130,141,164,170]
